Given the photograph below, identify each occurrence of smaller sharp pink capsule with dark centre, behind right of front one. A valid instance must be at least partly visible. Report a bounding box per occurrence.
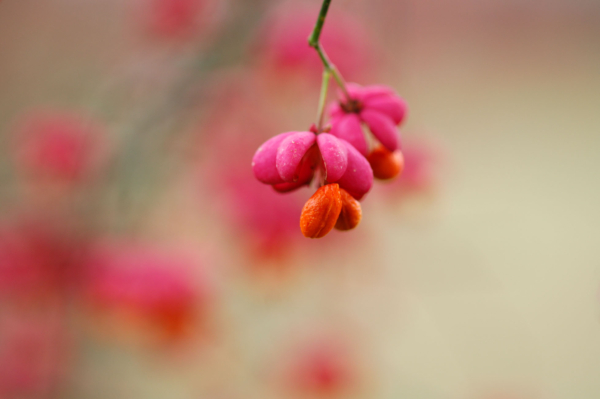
[330,83,407,156]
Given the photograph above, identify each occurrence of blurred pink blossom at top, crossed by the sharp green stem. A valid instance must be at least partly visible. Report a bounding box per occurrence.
[258,1,378,81]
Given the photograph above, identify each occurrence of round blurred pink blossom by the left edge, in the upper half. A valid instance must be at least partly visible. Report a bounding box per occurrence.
[13,109,107,181]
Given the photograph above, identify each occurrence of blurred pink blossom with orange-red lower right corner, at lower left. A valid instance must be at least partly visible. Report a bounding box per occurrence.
[88,245,212,339]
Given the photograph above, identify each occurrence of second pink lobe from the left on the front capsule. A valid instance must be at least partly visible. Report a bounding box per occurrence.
[275,132,316,182]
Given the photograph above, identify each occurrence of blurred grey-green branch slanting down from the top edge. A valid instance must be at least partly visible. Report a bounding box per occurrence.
[104,0,268,233]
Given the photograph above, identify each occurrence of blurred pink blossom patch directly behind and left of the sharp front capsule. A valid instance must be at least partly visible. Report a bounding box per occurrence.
[197,76,308,264]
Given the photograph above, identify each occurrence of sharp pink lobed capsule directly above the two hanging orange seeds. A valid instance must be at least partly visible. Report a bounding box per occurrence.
[252,132,373,200]
